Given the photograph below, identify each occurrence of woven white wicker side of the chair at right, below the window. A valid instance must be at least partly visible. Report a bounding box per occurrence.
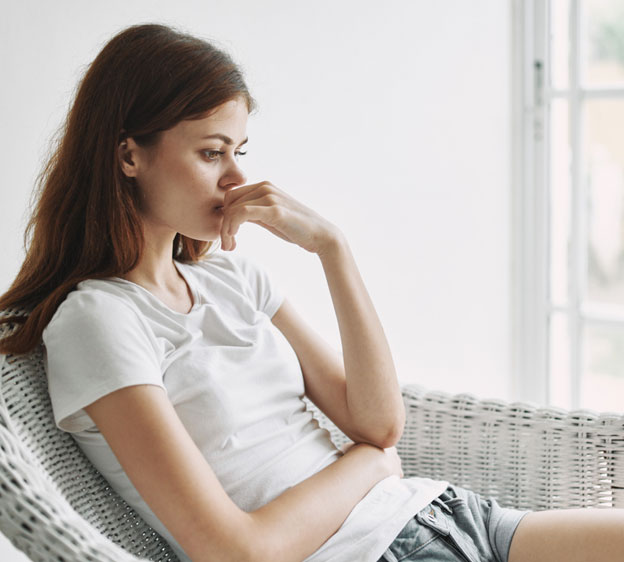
[310,385,624,510]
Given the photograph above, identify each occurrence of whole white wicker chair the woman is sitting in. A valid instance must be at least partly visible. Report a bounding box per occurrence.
[0,308,624,562]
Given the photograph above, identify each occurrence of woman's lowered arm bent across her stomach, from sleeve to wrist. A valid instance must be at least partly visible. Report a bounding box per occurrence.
[85,385,401,562]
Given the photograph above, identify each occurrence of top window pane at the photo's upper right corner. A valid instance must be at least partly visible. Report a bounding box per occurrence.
[581,0,624,86]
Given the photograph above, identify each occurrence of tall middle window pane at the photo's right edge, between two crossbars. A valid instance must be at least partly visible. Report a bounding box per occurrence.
[584,99,624,304]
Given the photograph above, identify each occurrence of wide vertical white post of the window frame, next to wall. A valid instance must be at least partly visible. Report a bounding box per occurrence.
[511,0,548,404]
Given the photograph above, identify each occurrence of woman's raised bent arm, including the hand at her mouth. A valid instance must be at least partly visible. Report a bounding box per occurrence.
[221,181,405,448]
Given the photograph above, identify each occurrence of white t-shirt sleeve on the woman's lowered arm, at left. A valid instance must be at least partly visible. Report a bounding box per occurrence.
[42,291,165,433]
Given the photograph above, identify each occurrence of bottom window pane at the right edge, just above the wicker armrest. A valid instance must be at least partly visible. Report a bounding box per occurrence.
[581,325,624,412]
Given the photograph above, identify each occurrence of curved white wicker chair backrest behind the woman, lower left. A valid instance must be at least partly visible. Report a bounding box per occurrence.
[0,313,178,562]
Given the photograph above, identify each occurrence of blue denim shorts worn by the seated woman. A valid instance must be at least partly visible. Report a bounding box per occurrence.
[378,485,530,562]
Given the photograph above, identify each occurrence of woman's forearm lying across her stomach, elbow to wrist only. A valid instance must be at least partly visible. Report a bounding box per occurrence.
[249,444,398,562]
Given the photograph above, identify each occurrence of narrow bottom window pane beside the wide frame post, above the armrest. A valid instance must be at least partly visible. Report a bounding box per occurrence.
[549,312,572,409]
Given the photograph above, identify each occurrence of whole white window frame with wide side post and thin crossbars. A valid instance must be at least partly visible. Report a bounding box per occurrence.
[511,0,624,409]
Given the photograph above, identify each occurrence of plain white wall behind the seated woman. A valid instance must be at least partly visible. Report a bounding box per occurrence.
[0,0,512,561]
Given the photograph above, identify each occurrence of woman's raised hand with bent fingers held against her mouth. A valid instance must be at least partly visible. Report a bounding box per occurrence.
[221,181,341,254]
